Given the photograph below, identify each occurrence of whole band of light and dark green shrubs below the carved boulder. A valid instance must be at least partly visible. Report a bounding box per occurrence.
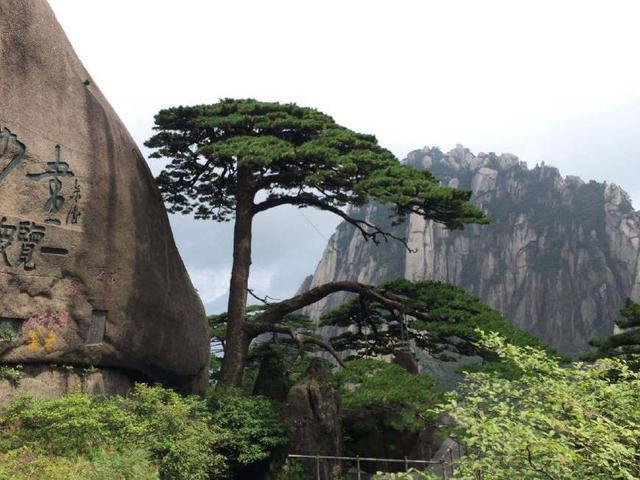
[0,385,283,480]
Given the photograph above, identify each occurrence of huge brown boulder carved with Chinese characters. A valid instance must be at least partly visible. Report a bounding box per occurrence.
[0,0,209,393]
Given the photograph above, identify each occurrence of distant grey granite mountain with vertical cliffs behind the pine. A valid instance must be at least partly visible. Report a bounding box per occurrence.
[302,146,640,354]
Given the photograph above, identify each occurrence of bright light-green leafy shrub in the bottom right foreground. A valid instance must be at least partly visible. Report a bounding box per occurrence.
[440,334,640,480]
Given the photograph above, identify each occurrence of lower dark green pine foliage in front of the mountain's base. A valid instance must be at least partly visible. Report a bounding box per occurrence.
[321,280,538,358]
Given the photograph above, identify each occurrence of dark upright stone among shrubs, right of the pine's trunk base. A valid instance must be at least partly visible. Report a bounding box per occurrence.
[282,360,343,480]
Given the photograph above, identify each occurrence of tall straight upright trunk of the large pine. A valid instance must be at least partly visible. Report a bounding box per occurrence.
[220,168,254,386]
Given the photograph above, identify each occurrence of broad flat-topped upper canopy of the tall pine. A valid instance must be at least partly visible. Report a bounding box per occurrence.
[146,99,486,227]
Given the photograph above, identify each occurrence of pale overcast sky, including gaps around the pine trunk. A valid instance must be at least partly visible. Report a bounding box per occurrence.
[50,0,640,312]
